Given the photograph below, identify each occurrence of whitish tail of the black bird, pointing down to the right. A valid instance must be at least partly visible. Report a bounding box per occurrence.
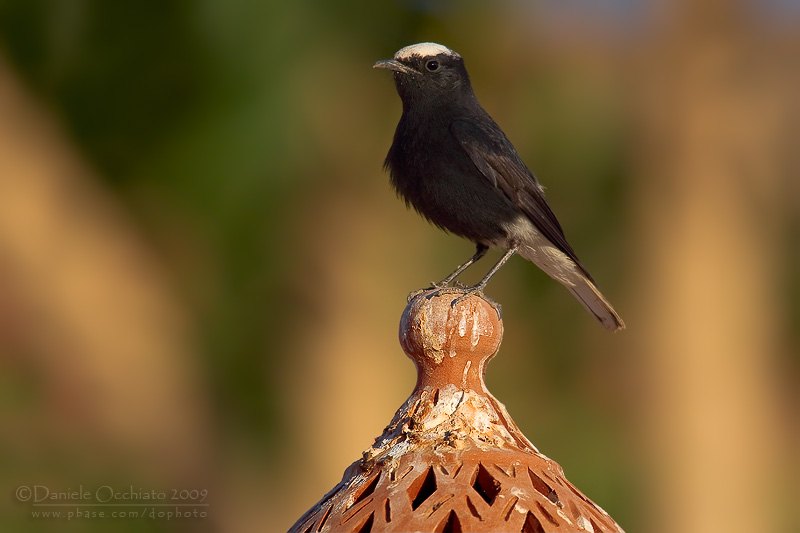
[519,246,625,331]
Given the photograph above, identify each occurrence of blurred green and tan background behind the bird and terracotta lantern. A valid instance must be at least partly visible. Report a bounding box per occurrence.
[0,0,800,533]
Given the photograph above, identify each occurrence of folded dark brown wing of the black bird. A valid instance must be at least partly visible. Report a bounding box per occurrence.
[450,119,592,280]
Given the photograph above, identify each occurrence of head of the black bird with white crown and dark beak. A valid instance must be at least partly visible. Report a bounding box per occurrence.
[373,43,472,107]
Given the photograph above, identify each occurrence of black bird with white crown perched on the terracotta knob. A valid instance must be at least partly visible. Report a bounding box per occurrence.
[374,43,625,331]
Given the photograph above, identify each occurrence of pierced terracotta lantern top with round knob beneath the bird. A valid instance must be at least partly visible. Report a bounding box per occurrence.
[290,291,622,533]
